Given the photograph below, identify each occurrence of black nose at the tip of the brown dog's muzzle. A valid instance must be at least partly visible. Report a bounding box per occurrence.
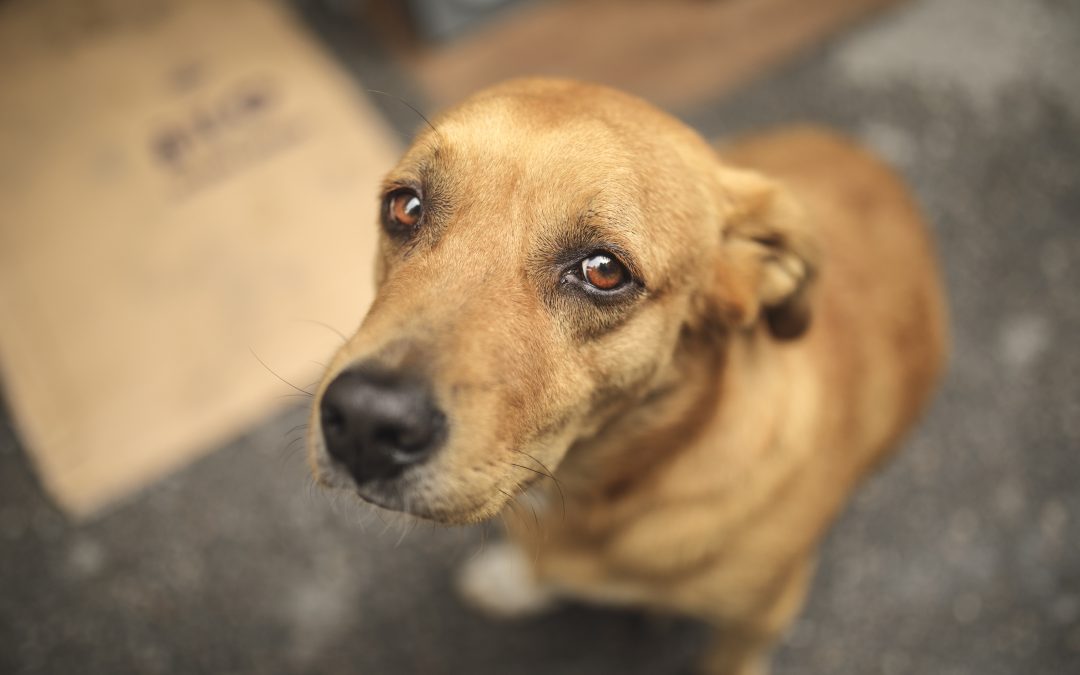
[319,366,446,484]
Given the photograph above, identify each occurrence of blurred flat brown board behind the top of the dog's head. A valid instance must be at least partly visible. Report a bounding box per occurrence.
[384,0,901,109]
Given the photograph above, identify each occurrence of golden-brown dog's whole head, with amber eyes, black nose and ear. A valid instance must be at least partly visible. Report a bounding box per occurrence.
[309,80,810,523]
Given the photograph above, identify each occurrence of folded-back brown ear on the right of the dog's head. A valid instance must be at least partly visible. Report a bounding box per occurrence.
[710,167,820,340]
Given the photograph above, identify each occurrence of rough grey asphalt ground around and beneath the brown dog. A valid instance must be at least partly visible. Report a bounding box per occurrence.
[0,0,1080,675]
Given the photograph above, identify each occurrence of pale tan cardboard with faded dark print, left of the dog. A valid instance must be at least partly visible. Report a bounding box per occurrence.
[0,0,397,517]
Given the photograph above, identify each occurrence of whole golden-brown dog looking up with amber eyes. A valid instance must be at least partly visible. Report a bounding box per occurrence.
[309,80,945,674]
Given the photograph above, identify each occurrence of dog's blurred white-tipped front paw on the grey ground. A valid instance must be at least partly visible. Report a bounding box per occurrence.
[457,542,555,619]
